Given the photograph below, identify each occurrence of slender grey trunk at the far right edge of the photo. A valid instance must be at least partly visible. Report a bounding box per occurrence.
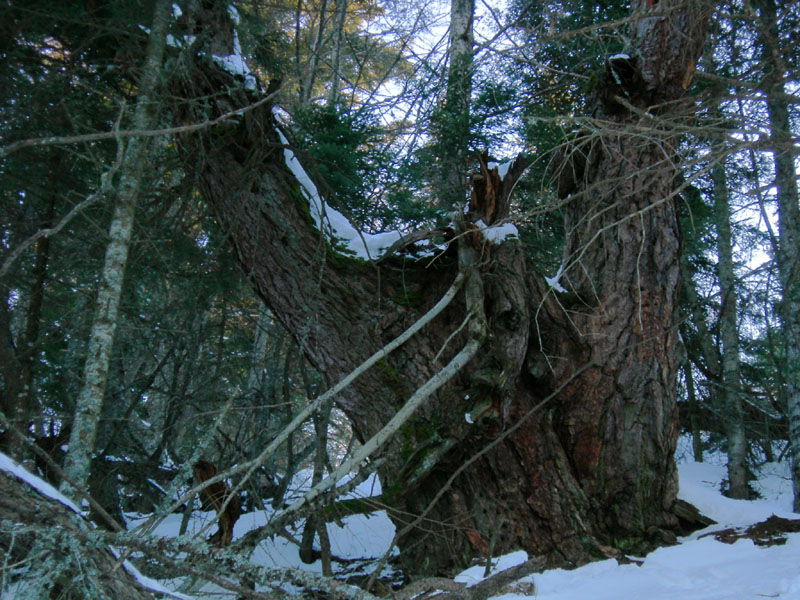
[754,0,800,511]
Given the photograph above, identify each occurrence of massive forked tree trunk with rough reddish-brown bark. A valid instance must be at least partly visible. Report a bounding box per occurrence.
[174,1,707,574]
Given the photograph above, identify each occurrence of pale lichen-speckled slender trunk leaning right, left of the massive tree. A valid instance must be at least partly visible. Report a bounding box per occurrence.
[64,0,170,494]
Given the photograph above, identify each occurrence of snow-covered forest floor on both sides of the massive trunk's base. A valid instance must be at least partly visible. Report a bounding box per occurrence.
[131,439,800,600]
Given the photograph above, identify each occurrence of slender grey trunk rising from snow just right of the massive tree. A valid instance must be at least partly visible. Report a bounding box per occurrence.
[711,144,750,500]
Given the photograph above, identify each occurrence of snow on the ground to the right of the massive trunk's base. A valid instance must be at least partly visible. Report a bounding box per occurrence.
[482,456,800,600]
